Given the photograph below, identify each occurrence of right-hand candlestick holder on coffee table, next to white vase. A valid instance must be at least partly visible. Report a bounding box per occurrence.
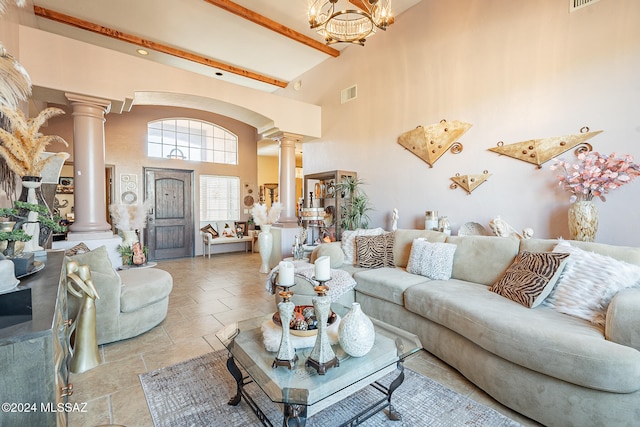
[305,286,340,375]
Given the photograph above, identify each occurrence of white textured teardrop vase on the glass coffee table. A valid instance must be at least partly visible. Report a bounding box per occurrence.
[338,302,376,357]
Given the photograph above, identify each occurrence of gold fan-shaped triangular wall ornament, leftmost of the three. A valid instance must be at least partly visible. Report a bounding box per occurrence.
[398,119,472,167]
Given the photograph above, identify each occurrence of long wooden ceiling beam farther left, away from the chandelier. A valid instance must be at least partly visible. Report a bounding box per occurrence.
[33,5,288,87]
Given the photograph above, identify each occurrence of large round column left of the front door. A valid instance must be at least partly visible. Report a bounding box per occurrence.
[65,93,113,240]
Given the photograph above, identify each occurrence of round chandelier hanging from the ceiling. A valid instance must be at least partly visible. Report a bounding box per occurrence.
[309,0,394,46]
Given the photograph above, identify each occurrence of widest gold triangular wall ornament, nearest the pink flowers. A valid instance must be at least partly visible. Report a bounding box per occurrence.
[489,126,602,168]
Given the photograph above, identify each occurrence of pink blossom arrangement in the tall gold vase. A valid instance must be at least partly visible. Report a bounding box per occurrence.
[551,151,640,203]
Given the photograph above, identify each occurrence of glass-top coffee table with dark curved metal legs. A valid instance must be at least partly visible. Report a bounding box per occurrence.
[216,304,422,427]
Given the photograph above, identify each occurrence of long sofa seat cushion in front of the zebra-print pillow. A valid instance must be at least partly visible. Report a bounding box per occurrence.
[404,279,640,393]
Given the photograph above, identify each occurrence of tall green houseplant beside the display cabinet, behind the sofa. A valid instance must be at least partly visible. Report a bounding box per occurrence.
[336,176,373,230]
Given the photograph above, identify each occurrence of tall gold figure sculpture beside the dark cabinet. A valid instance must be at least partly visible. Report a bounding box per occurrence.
[67,261,100,374]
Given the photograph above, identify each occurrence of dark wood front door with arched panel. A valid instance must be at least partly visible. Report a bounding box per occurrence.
[144,168,194,260]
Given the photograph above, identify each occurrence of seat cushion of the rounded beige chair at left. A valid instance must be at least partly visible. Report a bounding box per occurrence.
[119,268,173,313]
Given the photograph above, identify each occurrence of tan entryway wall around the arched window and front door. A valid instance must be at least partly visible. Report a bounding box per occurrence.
[42,106,258,227]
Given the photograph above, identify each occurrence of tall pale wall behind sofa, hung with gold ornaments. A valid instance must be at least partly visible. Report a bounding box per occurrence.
[279,0,640,246]
